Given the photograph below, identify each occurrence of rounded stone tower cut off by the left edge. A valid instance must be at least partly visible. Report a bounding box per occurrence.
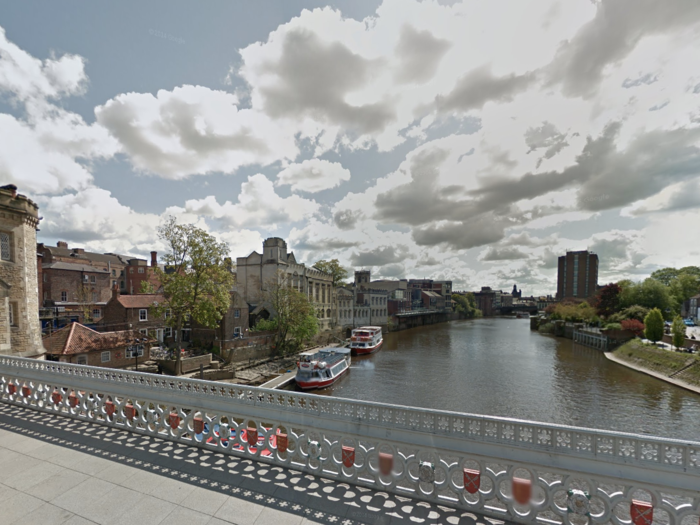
[0,184,45,359]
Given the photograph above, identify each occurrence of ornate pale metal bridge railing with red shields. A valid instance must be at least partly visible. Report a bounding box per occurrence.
[0,356,700,525]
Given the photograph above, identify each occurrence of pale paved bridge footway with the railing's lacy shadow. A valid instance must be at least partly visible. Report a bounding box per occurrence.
[0,403,503,525]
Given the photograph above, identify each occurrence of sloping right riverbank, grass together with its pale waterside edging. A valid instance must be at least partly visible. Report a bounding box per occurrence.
[604,339,700,394]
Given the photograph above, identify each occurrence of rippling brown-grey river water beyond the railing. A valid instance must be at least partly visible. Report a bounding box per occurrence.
[304,318,700,440]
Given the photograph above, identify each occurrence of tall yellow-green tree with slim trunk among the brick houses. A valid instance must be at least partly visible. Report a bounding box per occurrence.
[153,217,234,374]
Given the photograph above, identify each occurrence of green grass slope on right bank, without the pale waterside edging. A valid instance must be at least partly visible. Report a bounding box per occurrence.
[613,339,700,386]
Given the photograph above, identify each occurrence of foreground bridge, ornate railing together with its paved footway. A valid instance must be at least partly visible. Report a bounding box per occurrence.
[0,356,700,525]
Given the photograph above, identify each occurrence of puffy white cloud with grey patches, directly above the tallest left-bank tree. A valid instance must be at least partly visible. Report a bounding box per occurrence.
[95,86,298,179]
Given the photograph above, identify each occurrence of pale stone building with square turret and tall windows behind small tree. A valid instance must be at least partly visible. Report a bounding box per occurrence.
[236,237,337,330]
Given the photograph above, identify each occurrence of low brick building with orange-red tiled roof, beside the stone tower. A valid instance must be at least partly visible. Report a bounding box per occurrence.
[44,323,155,368]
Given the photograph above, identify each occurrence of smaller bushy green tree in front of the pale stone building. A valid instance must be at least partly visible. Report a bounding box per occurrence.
[264,271,318,352]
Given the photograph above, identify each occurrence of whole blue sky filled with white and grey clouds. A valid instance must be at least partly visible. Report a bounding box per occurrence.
[0,0,700,295]
